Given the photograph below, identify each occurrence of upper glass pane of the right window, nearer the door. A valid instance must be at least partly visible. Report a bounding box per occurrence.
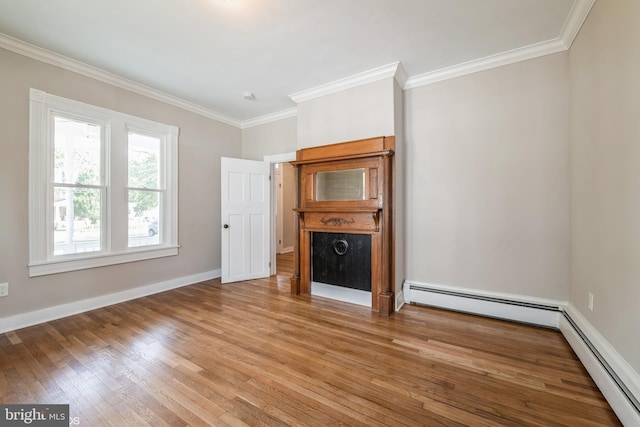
[129,132,160,189]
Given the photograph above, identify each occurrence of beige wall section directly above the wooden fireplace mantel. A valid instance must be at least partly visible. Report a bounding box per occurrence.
[298,77,395,148]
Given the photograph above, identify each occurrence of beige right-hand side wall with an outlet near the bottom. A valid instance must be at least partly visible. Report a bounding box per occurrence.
[569,0,640,372]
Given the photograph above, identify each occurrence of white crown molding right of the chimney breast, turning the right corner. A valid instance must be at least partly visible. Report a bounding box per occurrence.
[403,0,595,90]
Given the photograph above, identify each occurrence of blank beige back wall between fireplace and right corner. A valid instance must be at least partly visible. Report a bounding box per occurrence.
[405,52,569,300]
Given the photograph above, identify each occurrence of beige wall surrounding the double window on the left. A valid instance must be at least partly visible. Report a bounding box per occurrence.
[0,49,242,318]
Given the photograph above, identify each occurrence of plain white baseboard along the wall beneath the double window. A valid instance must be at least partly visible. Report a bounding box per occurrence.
[0,270,221,333]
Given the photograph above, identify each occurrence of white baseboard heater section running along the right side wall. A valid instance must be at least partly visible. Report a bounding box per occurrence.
[559,304,640,426]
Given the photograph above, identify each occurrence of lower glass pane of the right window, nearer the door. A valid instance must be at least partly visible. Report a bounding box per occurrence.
[129,190,162,248]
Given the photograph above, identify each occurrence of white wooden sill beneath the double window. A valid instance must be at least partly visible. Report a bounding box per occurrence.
[29,246,179,277]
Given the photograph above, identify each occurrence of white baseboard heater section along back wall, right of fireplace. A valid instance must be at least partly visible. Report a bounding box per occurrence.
[404,281,565,328]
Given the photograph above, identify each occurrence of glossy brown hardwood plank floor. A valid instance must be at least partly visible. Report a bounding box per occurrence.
[0,255,620,426]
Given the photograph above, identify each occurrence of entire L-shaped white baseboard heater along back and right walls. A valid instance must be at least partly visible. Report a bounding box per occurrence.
[403,281,640,426]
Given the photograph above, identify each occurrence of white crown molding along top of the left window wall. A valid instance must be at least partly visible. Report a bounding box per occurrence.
[0,33,241,128]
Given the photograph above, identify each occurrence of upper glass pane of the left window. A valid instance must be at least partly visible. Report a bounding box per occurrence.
[53,117,102,185]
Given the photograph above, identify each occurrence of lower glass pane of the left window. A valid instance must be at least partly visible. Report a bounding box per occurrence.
[53,187,102,255]
